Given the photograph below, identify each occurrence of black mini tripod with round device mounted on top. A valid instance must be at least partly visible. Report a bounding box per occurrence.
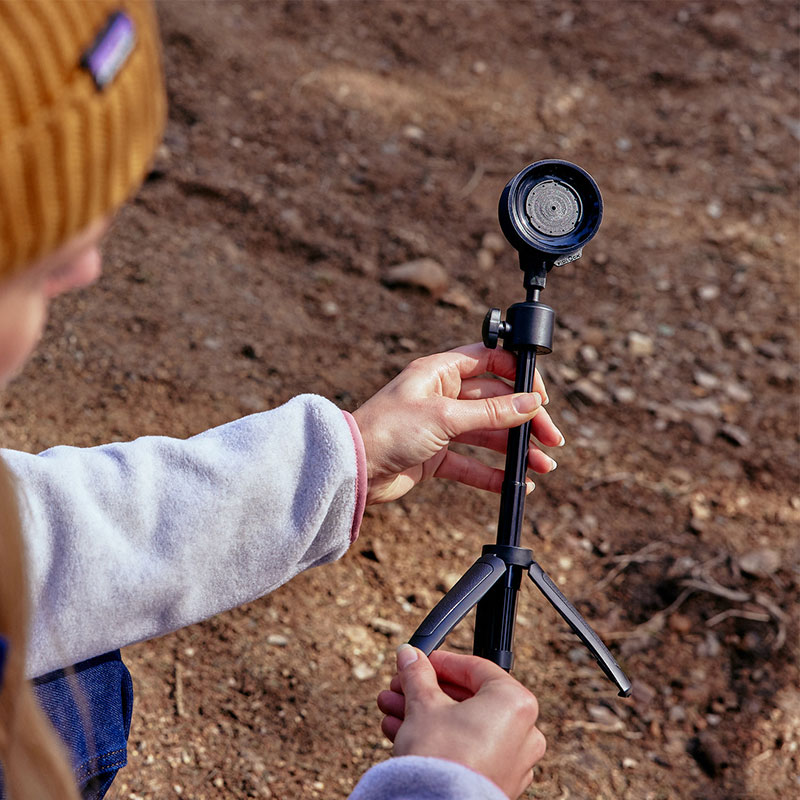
[409,160,631,697]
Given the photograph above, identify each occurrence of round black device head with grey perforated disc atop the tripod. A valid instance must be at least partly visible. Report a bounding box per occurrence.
[498,160,603,269]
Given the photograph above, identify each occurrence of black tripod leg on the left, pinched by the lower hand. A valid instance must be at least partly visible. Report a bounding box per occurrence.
[408,555,506,656]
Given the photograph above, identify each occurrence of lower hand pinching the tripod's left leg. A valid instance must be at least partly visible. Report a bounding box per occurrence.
[378,646,546,800]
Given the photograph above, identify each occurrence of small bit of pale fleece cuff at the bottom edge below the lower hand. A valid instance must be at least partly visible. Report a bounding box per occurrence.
[349,756,508,800]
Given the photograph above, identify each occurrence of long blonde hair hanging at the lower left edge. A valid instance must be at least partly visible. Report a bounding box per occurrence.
[0,459,79,800]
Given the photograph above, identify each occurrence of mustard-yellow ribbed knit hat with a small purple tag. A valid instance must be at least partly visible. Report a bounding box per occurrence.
[0,0,166,280]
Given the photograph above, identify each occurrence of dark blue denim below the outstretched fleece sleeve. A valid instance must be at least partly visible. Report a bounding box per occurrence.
[0,650,133,800]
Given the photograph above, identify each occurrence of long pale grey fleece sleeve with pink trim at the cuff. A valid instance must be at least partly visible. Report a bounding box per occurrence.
[2,395,366,676]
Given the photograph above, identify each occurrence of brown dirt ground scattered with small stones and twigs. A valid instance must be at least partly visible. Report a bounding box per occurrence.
[2,0,800,800]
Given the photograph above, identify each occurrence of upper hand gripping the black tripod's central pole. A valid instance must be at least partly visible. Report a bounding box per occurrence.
[353,344,564,503]
